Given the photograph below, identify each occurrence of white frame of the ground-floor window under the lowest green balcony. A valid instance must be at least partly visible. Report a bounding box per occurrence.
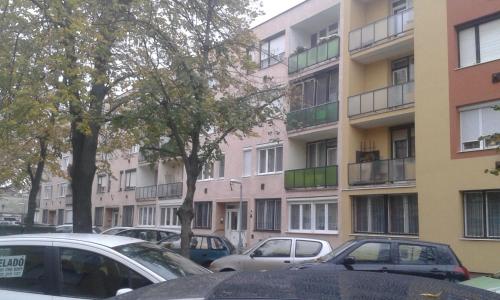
[288,199,339,234]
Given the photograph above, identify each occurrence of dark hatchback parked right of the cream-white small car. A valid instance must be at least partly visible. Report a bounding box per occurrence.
[297,239,469,281]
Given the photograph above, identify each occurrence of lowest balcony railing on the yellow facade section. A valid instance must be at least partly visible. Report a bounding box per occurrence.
[348,157,415,185]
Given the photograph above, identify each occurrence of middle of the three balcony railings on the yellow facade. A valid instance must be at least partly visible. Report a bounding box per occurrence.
[348,81,415,117]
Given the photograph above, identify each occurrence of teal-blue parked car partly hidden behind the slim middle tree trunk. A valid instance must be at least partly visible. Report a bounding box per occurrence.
[158,234,236,267]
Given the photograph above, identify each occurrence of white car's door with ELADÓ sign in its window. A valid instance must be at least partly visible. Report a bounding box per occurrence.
[0,242,55,300]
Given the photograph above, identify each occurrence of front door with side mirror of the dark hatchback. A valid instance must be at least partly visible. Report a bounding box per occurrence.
[337,241,394,272]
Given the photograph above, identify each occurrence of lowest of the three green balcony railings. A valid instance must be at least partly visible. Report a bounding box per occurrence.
[285,166,338,190]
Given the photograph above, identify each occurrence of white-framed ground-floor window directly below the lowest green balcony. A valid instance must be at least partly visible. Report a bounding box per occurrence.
[289,202,338,233]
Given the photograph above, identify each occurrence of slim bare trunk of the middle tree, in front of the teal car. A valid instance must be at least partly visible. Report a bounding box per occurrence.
[178,171,198,258]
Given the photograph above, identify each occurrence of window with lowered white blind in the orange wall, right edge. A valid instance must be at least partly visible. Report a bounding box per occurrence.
[460,102,500,151]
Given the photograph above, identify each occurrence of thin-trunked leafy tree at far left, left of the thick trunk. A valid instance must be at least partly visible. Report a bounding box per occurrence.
[0,0,67,226]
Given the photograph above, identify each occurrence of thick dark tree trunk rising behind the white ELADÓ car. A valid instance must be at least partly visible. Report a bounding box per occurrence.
[70,120,99,233]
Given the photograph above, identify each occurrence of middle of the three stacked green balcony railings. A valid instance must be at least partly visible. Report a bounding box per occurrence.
[286,102,339,131]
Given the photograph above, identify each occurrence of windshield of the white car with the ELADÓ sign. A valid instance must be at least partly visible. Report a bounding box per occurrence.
[113,243,210,280]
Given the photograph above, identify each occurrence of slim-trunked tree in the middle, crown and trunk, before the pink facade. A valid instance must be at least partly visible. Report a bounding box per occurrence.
[122,0,284,256]
